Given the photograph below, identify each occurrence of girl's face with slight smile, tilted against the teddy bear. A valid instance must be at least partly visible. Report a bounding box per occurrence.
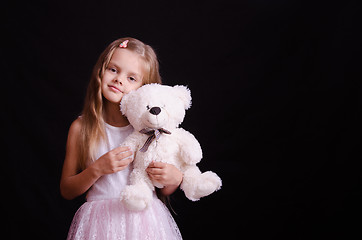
[101,48,144,104]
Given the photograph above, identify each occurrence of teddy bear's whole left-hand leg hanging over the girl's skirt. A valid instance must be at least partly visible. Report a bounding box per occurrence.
[121,170,153,211]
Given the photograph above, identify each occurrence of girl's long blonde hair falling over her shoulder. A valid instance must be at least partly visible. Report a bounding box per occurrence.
[79,37,161,169]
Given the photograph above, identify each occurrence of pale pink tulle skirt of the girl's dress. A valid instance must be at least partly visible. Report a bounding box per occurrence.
[67,198,182,240]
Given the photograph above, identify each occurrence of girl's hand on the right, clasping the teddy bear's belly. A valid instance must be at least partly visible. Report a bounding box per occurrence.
[146,162,183,191]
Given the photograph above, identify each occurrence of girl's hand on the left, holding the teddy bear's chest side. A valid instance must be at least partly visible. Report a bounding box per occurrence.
[91,146,133,176]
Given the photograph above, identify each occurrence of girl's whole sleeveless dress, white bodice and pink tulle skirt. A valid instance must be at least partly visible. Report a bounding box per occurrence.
[67,124,182,240]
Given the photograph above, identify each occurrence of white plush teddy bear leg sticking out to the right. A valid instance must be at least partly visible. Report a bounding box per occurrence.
[181,166,222,201]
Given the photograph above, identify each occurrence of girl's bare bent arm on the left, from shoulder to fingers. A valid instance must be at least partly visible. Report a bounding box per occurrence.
[60,118,133,200]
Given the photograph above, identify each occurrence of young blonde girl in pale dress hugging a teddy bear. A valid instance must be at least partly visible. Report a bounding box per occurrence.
[60,38,182,240]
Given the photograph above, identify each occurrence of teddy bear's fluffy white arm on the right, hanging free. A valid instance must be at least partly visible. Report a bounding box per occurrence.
[173,128,202,165]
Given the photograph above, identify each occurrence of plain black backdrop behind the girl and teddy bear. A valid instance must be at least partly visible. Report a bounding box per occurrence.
[1,0,362,239]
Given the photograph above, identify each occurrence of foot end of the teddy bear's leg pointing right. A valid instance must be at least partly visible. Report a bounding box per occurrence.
[194,171,222,199]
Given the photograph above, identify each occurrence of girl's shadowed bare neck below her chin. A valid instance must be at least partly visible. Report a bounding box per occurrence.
[103,101,129,127]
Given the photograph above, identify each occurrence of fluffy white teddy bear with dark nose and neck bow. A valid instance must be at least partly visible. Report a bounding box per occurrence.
[121,84,221,211]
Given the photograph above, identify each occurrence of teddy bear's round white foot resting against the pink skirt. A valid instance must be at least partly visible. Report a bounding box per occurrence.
[121,185,152,211]
